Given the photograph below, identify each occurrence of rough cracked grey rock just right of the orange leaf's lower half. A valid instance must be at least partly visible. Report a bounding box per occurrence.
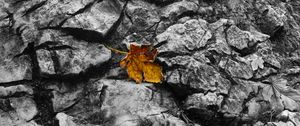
[162,56,230,94]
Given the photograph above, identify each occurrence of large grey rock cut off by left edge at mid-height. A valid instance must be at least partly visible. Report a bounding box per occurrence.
[0,26,32,83]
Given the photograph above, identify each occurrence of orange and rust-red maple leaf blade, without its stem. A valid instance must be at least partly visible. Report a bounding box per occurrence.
[120,44,163,83]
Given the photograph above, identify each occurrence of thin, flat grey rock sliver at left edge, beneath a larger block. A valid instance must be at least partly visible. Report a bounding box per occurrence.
[0,85,33,97]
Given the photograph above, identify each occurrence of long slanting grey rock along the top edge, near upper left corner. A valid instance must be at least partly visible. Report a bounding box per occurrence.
[12,0,93,28]
